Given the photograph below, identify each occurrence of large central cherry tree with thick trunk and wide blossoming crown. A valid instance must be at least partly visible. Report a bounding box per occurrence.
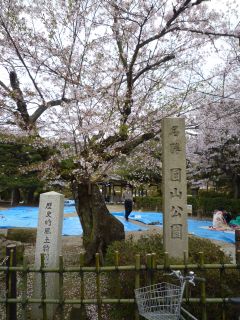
[0,0,239,260]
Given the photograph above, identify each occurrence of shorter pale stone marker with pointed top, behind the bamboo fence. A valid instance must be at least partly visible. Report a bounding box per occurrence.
[32,191,64,320]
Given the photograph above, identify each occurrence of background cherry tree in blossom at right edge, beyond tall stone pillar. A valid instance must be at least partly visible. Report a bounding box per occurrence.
[188,31,240,198]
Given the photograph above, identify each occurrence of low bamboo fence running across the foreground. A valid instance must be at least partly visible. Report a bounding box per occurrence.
[0,248,240,320]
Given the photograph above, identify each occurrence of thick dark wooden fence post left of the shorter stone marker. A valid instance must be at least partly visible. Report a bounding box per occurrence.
[6,244,17,320]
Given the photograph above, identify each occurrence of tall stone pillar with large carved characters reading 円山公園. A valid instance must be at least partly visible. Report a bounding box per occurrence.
[162,118,188,258]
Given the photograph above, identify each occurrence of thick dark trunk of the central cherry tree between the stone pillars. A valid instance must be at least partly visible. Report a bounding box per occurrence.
[73,183,125,263]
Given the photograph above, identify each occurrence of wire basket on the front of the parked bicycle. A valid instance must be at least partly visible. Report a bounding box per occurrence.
[135,282,184,320]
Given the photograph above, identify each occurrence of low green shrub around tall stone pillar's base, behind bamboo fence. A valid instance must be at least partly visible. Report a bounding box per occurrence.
[106,235,234,320]
